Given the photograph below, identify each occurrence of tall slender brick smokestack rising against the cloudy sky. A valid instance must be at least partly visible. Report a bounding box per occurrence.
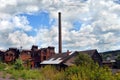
[58,12,62,54]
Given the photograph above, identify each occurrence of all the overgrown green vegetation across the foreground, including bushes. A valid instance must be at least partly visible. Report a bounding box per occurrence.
[0,55,120,80]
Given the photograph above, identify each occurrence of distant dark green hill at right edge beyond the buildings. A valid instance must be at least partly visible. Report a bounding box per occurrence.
[100,50,120,60]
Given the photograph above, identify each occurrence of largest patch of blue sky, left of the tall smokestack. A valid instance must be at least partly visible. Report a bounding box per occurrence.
[23,11,51,28]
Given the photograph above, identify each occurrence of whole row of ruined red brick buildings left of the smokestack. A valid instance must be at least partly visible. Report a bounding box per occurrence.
[3,45,55,68]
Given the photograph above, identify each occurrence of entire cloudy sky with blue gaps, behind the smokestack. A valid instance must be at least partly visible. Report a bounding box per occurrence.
[0,0,120,51]
